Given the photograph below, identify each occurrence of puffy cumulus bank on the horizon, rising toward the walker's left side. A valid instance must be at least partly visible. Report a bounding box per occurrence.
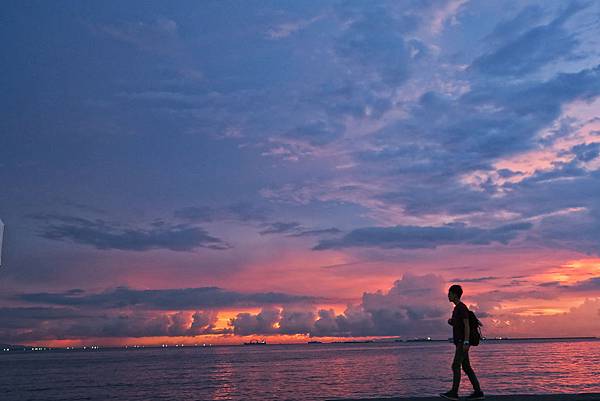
[231,273,448,337]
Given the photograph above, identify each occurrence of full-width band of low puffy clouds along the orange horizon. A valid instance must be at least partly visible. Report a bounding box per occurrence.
[5,273,600,342]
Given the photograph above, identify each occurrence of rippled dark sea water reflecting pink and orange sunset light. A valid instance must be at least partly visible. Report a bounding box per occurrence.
[0,341,600,401]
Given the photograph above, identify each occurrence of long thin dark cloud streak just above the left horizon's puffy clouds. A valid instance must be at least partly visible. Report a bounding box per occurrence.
[19,287,319,310]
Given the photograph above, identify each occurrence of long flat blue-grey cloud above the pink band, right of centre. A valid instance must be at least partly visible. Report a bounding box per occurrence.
[313,223,532,250]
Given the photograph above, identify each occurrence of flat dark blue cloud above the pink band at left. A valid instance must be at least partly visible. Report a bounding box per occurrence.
[33,215,230,252]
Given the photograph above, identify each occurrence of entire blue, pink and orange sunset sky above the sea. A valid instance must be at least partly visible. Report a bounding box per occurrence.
[0,0,600,346]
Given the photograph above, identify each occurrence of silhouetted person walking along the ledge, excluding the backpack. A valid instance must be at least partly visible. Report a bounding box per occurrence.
[440,284,484,400]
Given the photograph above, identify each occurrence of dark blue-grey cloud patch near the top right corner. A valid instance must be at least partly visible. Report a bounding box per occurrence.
[472,2,587,76]
